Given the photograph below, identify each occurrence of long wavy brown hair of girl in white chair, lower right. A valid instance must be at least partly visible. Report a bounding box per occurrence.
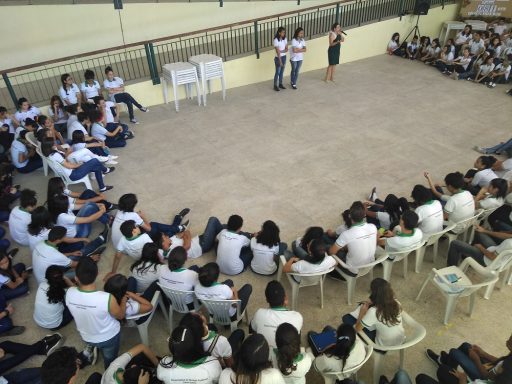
[370,277,402,326]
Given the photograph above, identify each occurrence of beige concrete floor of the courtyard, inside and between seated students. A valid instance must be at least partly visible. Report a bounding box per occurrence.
[6,55,512,383]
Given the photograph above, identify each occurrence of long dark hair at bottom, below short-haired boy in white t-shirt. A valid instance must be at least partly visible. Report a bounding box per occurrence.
[276,323,300,376]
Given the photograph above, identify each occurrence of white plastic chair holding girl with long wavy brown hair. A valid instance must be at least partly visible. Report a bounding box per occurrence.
[359,311,427,384]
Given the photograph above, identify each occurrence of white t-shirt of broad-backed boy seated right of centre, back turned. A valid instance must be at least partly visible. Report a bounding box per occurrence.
[336,222,377,273]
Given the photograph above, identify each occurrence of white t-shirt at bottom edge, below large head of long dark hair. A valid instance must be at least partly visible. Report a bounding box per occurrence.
[156,356,222,384]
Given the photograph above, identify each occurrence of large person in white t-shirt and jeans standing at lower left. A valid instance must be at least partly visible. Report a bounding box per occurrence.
[66,257,128,368]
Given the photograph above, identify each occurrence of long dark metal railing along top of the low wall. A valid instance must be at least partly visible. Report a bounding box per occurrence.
[0,0,456,109]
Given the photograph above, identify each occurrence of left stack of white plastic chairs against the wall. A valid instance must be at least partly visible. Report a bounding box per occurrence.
[162,62,201,112]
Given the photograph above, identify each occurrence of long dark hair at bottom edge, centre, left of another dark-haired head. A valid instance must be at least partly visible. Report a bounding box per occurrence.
[233,333,272,384]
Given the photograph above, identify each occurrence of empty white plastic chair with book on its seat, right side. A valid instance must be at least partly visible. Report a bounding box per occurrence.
[416,257,499,325]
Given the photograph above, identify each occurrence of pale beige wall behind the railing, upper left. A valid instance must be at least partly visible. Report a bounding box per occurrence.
[0,0,332,69]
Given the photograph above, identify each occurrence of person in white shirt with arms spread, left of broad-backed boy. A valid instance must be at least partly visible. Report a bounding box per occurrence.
[283,239,336,281]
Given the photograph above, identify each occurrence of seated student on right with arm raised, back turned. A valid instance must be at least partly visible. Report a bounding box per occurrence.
[424,172,475,233]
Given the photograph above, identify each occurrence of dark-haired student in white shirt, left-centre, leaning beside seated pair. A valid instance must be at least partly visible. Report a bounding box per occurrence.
[111,220,153,274]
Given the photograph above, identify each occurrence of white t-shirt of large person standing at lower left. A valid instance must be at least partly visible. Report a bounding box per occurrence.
[66,287,121,343]
